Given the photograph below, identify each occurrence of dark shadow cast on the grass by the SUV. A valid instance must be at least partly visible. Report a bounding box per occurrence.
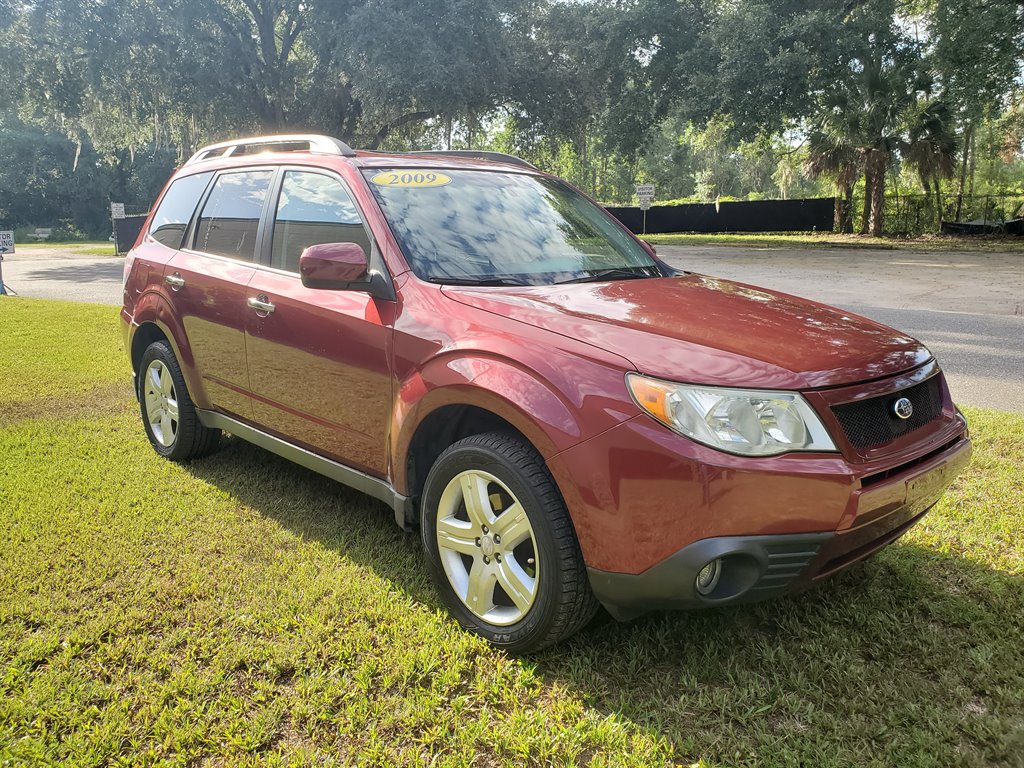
[190,438,1024,766]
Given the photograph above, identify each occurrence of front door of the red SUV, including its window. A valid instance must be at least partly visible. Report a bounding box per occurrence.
[246,168,395,476]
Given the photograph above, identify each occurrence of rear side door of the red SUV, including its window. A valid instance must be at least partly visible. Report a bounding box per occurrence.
[164,168,275,421]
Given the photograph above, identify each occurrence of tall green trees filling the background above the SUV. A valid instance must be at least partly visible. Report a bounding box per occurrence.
[0,0,1024,233]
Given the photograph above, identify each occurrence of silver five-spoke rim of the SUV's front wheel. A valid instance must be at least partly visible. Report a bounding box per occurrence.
[436,470,541,626]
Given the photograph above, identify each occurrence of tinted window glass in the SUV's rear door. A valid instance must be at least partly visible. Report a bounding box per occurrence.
[196,171,273,261]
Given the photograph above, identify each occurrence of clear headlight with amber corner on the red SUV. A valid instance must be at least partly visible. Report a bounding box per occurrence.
[626,374,836,456]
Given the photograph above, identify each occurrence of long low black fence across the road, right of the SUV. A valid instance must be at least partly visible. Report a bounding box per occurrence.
[608,198,836,234]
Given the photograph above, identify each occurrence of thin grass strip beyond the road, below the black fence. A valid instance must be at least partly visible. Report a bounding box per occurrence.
[642,232,1024,253]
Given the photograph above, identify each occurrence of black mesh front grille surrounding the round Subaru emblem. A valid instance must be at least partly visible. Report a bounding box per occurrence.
[833,376,942,449]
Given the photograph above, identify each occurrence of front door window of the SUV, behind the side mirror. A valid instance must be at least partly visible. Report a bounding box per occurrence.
[270,171,370,272]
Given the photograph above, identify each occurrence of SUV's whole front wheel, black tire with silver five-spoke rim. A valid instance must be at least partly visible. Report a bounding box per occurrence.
[420,432,597,653]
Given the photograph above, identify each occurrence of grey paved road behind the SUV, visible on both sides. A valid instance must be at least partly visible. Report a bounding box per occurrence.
[6,246,1024,413]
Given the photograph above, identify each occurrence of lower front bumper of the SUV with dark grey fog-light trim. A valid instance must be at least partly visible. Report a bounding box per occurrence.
[588,435,972,621]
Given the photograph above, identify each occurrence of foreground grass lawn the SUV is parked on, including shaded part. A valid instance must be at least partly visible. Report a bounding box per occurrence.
[0,299,1024,767]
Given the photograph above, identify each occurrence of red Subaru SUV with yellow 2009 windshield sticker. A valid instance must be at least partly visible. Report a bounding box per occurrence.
[121,136,971,652]
